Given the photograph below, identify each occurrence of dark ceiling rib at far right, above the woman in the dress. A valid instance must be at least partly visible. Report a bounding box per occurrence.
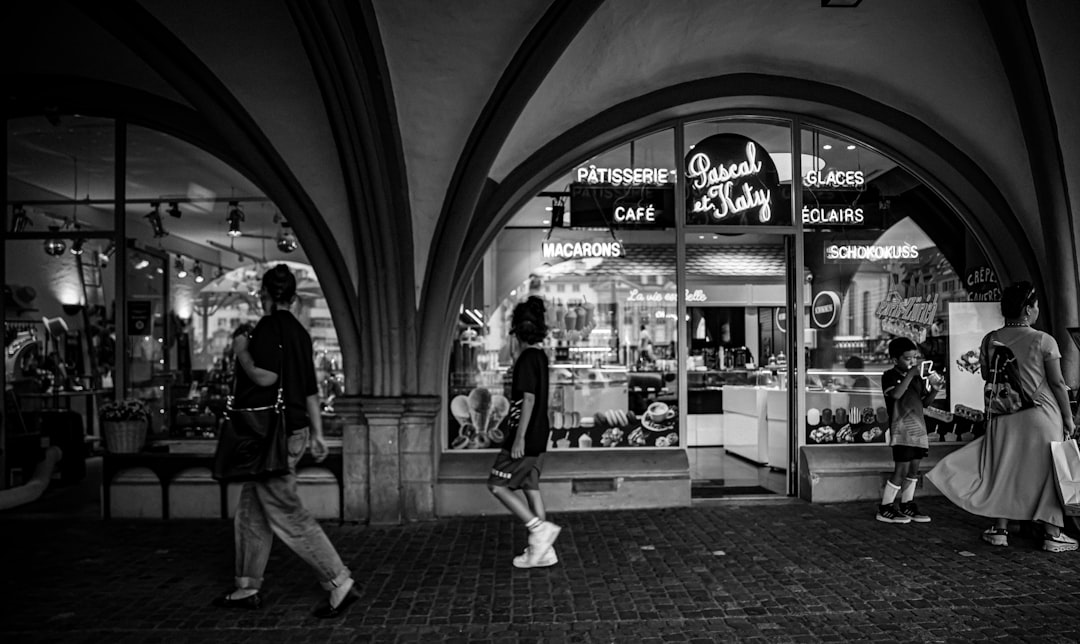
[980,0,1080,380]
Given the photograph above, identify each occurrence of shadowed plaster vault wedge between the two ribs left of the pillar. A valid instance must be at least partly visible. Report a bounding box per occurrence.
[143,0,359,286]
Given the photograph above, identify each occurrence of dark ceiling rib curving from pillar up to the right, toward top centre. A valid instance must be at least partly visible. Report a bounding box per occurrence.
[419,0,603,393]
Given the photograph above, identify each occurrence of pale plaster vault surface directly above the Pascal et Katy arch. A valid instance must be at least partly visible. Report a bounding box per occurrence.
[491,0,1043,254]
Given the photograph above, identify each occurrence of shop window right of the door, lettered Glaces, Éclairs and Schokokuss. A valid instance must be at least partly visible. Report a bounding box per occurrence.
[801,124,1000,444]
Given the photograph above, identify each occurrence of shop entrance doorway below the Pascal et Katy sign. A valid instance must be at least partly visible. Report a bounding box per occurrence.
[680,232,794,498]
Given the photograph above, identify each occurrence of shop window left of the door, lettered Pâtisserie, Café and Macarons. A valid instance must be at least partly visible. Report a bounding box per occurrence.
[446,130,680,450]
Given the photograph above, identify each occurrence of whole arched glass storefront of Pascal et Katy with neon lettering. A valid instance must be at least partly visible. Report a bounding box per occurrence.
[437,117,997,513]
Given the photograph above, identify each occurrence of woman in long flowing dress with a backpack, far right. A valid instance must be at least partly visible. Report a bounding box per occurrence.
[927,282,1077,552]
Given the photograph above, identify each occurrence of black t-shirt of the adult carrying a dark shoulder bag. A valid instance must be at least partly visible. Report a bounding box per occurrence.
[233,311,319,431]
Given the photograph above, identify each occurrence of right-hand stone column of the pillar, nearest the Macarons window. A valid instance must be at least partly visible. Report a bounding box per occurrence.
[401,397,442,521]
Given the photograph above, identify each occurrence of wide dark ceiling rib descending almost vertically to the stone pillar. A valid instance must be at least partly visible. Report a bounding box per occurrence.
[287,0,417,397]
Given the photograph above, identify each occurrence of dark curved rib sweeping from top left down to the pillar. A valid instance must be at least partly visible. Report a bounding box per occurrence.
[68,0,361,387]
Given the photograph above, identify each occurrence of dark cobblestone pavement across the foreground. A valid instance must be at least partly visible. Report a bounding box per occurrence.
[0,499,1080,644]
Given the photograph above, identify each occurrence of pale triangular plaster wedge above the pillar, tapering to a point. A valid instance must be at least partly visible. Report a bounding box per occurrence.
[373,0,549,298]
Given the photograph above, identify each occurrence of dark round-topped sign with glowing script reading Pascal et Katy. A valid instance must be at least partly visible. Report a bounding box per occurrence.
[686,134,791,226]
